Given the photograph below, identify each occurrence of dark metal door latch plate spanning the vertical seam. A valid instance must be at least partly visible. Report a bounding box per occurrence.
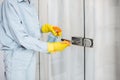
[71,37,93,48]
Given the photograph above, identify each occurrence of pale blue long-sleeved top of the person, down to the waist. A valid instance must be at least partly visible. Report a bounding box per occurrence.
[0,0,47,52]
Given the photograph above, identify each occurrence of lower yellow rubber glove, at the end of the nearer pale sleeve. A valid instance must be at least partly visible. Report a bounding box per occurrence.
[48,41,70,53]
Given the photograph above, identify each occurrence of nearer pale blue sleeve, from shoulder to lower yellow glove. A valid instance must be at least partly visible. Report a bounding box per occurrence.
[4,2,47,52]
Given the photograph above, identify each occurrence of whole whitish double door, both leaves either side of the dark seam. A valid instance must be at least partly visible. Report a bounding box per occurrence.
[37,0,120,80]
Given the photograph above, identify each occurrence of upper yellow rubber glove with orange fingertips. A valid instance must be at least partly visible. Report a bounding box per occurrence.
[41,24,62,36]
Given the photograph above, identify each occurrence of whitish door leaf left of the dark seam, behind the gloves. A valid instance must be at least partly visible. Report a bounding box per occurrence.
[39,0,85,80]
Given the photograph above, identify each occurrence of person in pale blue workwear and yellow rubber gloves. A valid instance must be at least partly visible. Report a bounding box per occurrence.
[0,0,70,80]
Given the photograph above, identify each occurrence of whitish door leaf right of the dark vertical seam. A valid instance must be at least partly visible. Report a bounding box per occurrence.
[86,0,120,80]
